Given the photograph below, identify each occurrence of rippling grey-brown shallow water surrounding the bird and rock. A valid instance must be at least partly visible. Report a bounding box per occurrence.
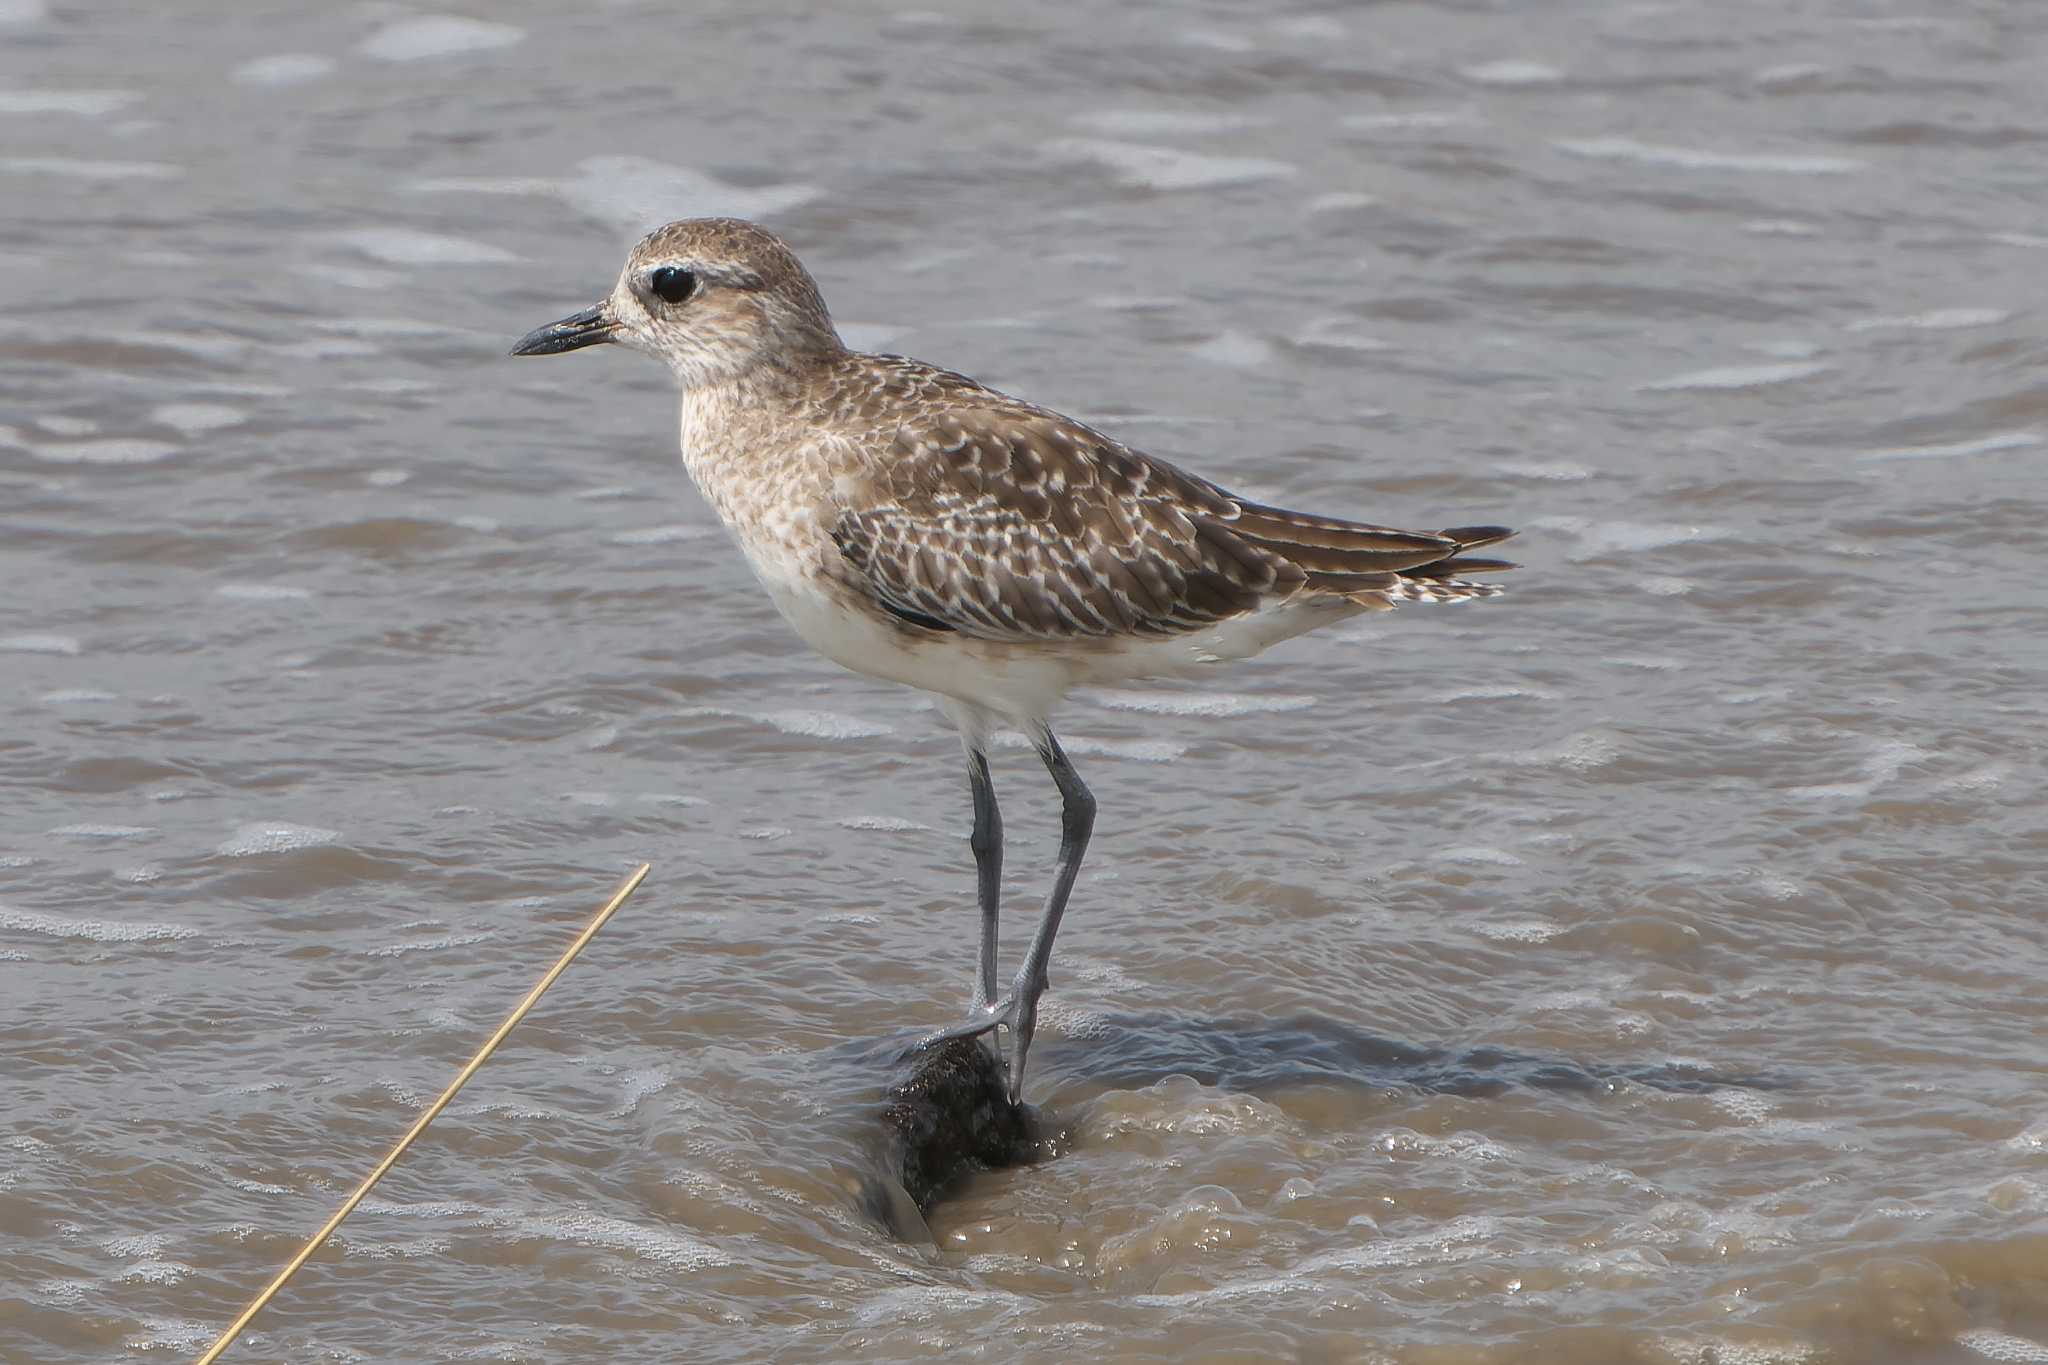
[0,0,2048,1365]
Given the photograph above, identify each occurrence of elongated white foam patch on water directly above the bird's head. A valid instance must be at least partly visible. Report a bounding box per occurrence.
[412,156,823,231]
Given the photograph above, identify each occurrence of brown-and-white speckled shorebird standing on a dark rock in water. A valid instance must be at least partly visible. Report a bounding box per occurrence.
[512,219,1513,1103]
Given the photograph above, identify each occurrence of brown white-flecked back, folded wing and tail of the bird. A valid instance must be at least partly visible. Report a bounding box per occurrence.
[831,358,1511,641]
